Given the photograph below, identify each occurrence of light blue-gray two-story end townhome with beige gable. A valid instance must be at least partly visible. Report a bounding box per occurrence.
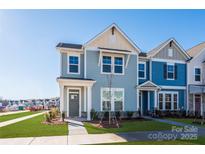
[57,24,140,120]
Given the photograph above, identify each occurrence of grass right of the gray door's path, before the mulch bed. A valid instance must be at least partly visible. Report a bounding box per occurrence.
[84,120,175,134]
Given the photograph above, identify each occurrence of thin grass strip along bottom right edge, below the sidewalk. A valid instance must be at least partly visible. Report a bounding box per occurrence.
[97,136,205,145]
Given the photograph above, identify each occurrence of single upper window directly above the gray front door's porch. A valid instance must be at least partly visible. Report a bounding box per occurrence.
[68,56,80,74]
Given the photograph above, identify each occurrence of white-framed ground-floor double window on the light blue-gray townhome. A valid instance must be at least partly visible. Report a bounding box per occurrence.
[101,88,124,111]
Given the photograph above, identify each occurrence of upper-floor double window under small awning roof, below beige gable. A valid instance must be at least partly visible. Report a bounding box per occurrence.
[102,56,124,74]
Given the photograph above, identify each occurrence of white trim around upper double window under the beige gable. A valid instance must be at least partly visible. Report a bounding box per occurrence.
[100,53,125,75]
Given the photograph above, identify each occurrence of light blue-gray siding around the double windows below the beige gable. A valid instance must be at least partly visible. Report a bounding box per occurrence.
[86,51,137,111]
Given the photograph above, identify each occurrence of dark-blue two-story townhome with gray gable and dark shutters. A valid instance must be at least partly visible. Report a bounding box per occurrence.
[137,38,190,114]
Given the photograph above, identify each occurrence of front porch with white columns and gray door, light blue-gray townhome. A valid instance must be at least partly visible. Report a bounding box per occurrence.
[57,77,96,120]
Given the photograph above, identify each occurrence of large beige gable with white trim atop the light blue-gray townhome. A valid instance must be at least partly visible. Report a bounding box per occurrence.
[84,24,140,53]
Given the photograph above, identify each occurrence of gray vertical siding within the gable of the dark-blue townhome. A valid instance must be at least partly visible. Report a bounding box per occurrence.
[154,44,185,60]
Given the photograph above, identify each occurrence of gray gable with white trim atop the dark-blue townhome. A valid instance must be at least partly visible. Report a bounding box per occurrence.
[148,38,190,60]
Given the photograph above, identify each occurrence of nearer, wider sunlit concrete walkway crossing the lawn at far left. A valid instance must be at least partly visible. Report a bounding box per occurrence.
[0,111,47,127]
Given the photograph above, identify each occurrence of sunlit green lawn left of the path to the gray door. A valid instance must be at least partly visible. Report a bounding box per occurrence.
[0,115,68,138]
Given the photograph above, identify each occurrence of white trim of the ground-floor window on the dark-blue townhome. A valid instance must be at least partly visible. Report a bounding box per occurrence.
[158,91,179,111]
